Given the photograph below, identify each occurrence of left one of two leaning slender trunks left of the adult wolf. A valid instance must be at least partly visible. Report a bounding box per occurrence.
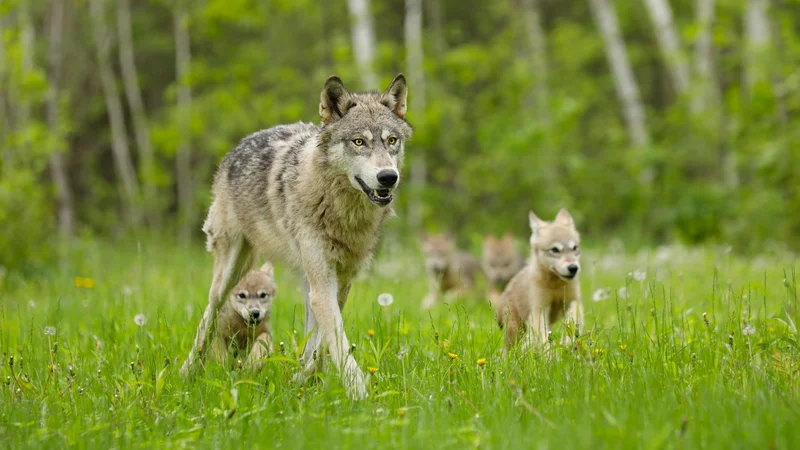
[89,0,141,225]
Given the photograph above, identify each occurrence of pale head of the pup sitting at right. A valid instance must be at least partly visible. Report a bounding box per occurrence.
[529,208,581,280]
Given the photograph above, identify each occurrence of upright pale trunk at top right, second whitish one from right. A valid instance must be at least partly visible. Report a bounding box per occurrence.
[692,0,717,112]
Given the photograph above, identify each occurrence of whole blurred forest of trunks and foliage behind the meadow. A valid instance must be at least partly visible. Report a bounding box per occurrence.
[0,0,800,267]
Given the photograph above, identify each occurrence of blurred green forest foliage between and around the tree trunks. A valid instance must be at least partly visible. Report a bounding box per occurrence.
[0,0,800,266]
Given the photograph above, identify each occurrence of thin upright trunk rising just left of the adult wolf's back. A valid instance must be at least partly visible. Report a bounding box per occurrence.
[173,9,194,242]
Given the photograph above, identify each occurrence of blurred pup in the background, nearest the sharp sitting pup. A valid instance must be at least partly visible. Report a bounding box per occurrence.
[481,233,522,317]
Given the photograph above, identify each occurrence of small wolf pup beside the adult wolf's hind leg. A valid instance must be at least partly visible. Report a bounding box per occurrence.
[212,263,277,370]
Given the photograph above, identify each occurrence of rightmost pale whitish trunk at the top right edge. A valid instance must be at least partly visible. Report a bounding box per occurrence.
[744,0,770,94]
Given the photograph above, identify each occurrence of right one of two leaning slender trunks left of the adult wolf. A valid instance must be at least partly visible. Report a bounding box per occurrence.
[117,0,158,221]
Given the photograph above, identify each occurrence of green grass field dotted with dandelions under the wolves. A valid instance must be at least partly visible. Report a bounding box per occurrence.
[0,242,800,449]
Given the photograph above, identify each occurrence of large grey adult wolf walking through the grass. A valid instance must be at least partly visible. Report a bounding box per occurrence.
[181,74,412,398]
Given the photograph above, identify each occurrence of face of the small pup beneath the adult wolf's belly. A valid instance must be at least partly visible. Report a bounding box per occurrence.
[229,263,277,327]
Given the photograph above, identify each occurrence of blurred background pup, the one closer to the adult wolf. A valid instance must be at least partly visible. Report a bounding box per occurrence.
[422,234,480,309]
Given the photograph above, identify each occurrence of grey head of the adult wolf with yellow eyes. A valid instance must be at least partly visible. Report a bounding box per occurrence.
[319,75,411,206]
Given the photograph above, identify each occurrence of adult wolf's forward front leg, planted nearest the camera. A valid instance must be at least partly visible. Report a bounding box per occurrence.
[303,252,367,400]
